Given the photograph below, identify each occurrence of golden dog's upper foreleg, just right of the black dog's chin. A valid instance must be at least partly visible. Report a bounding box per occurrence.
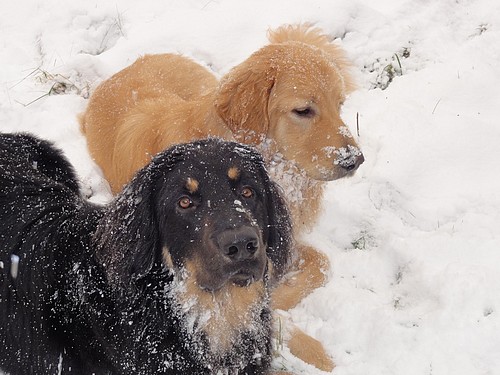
[272,244,330,311]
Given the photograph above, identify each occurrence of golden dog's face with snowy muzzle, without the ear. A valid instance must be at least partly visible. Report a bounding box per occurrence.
[268,41,363,181]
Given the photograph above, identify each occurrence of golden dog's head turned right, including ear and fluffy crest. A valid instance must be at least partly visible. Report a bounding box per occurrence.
[215,25,364,181]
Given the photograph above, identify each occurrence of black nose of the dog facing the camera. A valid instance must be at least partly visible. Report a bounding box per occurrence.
[217,227,260,261]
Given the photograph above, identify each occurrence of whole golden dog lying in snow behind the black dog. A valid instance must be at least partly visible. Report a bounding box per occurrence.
[80,24,364,370]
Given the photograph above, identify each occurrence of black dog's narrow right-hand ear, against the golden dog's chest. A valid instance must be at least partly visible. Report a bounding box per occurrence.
[266,173,293,280]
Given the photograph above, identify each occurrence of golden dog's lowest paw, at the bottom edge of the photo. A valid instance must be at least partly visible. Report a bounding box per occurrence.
[288,327,335,372]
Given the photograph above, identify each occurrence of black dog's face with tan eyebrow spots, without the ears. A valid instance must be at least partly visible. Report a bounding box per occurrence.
[157,147,280,293]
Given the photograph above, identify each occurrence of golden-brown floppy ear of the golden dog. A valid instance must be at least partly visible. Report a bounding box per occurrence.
[215,59,275,144]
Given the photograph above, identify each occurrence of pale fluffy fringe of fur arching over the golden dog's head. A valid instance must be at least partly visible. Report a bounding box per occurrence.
[267,23,356,95]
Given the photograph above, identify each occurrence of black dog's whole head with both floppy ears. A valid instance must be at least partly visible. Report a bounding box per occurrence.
[96,139,291,292]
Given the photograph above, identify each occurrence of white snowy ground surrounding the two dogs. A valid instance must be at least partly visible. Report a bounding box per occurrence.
[0,0,500,375]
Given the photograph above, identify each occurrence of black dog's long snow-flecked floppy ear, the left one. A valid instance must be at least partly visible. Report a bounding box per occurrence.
[94,147,182,287]
